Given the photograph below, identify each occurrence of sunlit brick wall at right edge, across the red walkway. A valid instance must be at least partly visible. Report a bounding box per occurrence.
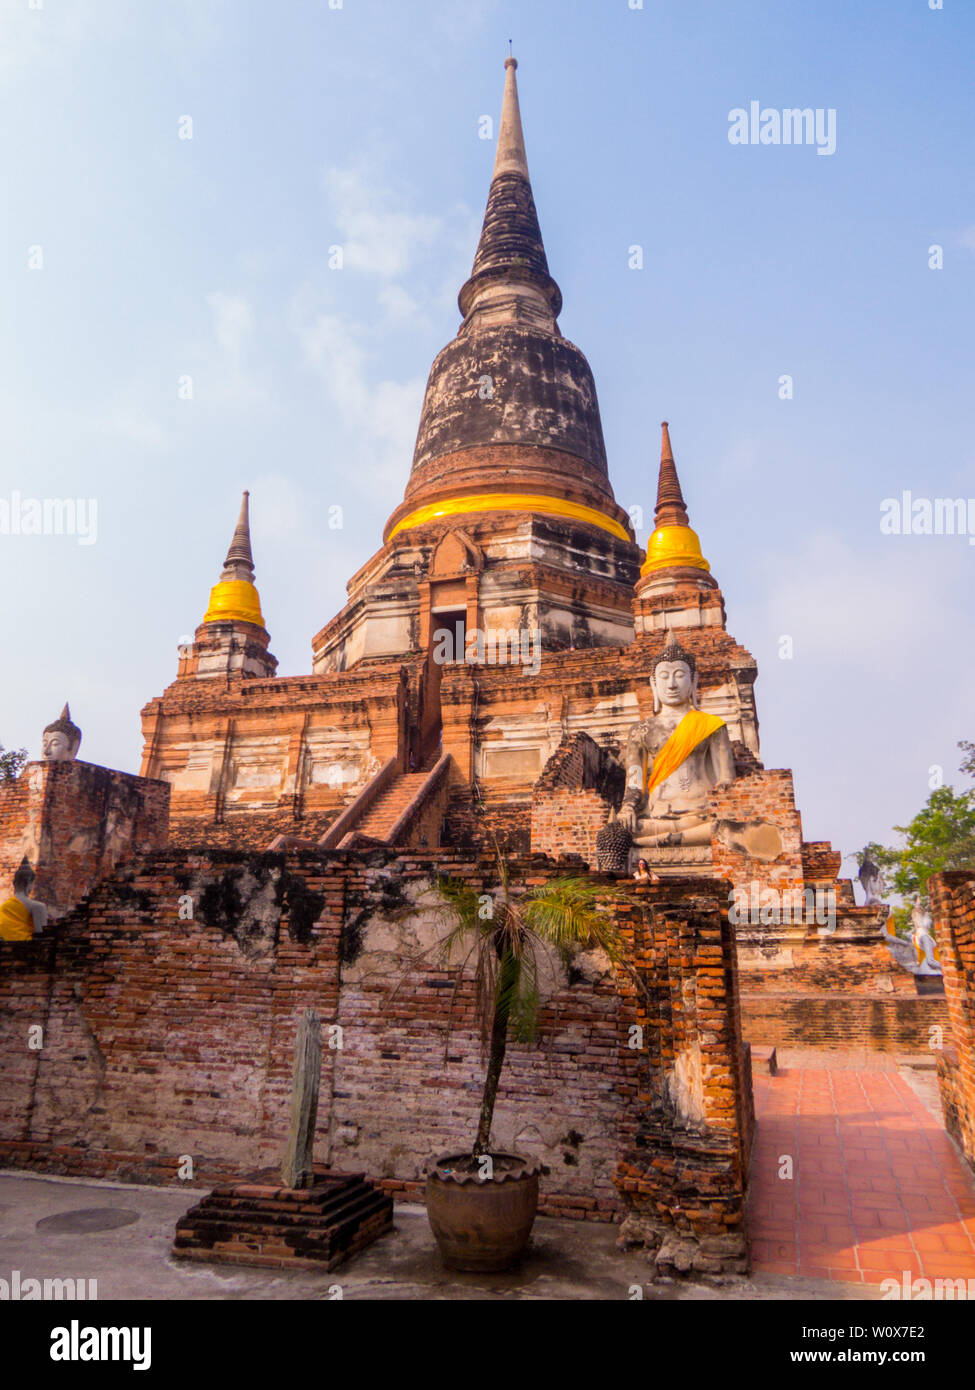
[928,872,975,1168]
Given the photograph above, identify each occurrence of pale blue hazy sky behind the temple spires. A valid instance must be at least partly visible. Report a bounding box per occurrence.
[0,0,975,870]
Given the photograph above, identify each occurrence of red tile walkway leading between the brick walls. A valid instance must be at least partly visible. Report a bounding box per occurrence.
[748,1068,975,1284]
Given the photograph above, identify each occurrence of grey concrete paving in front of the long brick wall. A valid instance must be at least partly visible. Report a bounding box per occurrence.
[0,1170,878,1301]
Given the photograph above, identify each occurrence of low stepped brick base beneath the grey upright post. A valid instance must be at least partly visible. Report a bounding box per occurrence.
[172,1173,392,1269]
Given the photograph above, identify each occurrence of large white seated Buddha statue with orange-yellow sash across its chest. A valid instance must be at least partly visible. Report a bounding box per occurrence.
[619,634,734,848]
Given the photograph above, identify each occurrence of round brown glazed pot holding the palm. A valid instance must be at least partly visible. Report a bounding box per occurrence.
[427,1154,541,1270]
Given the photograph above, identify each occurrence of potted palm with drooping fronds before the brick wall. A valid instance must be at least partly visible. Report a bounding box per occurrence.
[427,851,620,1270]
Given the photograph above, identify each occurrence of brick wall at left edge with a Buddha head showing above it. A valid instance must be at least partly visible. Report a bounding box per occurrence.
[0,762,170,915]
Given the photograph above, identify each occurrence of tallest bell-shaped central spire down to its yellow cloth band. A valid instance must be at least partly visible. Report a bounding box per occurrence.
[384,57,633,563]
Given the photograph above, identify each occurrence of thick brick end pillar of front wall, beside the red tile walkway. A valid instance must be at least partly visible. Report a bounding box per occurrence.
[618,878,754,1273]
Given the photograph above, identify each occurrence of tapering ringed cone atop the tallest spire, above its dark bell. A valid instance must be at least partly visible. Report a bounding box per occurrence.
[458,58,562,335]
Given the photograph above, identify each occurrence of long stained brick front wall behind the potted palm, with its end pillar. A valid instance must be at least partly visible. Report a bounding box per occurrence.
[0,849,750,1258]
